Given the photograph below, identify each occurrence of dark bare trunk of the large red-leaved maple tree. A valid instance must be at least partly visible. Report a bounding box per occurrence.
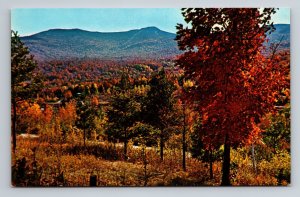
[221,136,231,186]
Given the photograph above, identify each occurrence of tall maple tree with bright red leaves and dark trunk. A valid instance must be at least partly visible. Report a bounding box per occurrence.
[176,8,288,185]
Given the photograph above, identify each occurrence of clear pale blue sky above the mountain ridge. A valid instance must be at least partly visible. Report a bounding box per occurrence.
[11,8,290,36]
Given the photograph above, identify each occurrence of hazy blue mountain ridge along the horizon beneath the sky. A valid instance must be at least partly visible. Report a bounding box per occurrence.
[21,24,290,60]
